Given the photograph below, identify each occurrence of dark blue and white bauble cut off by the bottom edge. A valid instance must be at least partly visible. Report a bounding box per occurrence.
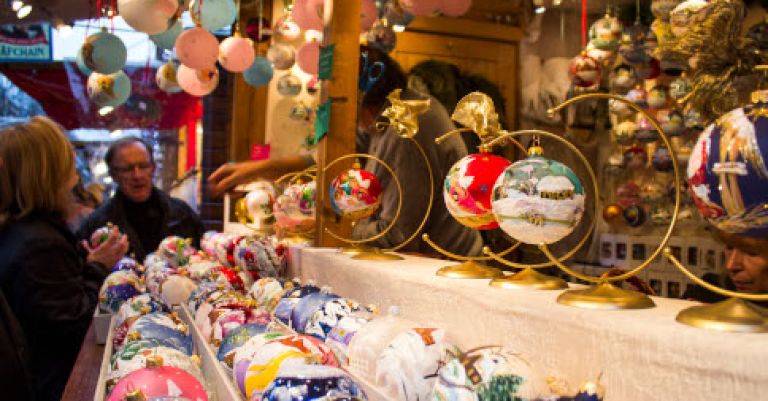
[261,365,367,401]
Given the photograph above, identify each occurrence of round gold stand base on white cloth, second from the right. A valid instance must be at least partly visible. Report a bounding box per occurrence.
[557,283,656,310]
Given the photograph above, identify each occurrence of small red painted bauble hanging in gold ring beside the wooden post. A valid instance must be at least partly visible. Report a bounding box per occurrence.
[330,166,382,220]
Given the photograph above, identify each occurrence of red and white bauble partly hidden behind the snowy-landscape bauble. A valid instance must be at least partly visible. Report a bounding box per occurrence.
[443,153,510,230]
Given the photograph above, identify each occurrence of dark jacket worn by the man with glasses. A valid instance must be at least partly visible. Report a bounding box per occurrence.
[77,188,204,261]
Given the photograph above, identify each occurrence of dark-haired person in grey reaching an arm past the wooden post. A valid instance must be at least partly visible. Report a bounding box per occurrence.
[209,46,481,255]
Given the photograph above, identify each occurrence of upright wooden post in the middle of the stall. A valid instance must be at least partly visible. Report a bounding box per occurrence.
[315,0,360,246]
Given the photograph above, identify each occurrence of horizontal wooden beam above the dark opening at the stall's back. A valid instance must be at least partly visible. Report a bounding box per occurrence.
[406,17,523,42]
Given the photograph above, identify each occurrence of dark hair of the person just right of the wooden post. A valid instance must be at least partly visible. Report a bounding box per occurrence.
[358,46,408,108]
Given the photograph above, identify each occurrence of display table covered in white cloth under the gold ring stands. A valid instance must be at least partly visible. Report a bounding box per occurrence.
[289,248,768,401]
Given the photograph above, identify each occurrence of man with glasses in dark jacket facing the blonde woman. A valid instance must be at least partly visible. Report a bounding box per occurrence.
[77,138,204,261]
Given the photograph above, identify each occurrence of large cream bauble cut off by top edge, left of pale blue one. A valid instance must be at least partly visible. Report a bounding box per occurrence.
[117,0,179,35]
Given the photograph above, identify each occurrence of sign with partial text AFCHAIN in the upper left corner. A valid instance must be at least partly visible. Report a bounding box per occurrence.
[0,24,53,62]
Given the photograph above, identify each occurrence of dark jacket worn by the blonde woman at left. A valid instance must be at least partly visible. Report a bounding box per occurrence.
[0,213,107,401]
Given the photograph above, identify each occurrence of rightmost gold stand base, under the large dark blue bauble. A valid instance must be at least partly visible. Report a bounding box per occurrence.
[675,298,768,333]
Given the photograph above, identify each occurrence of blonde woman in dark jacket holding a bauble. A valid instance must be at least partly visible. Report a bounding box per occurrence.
[0,117,128,401]
